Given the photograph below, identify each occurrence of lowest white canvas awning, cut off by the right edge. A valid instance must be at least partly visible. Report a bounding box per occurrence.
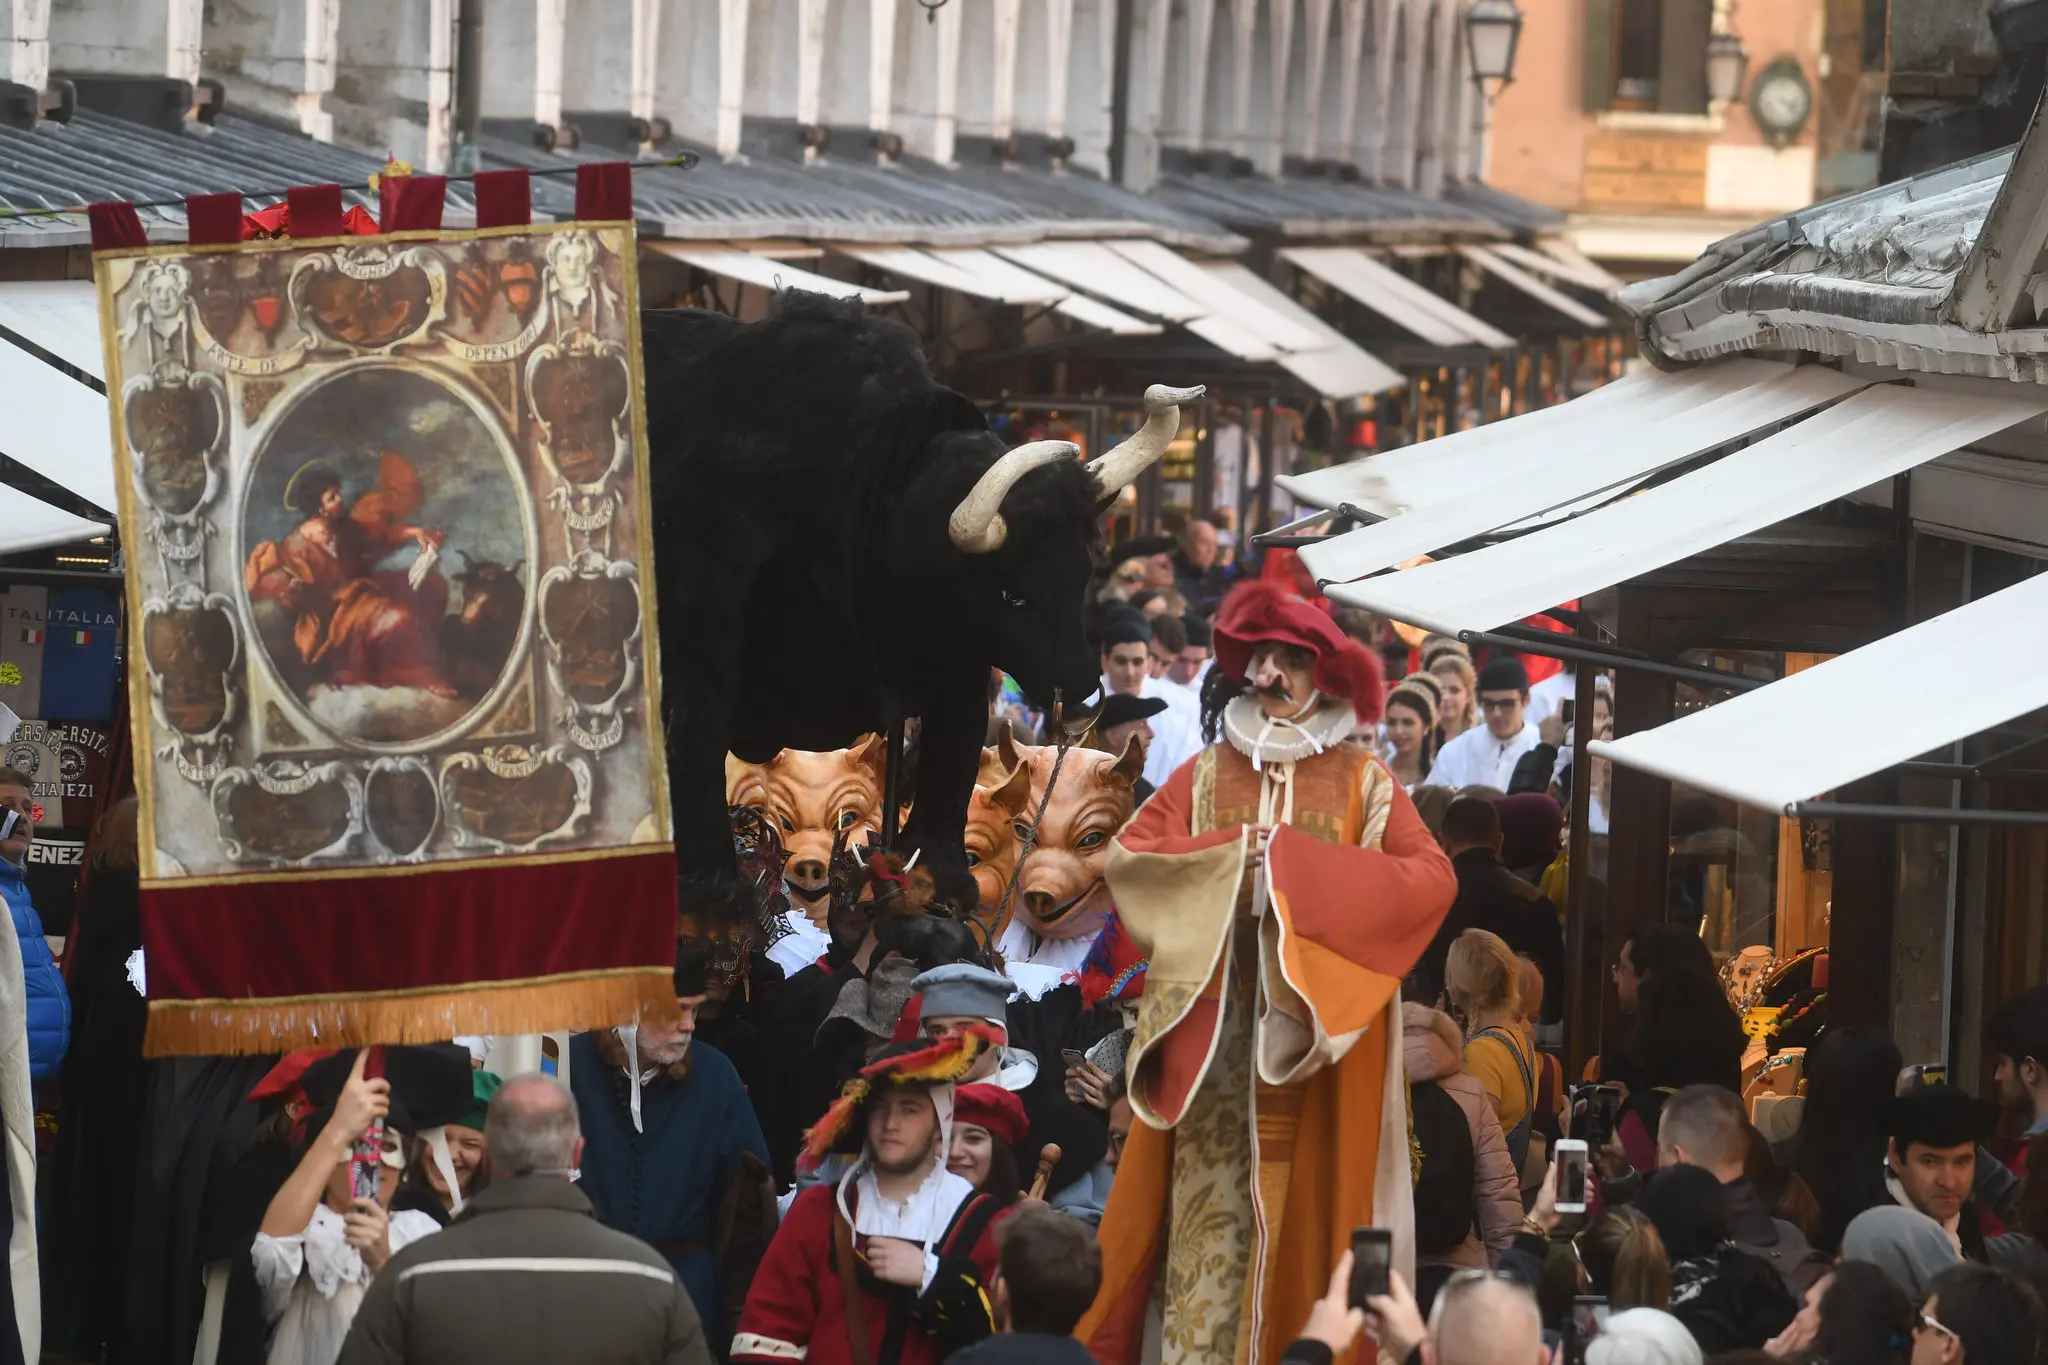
[1593,573,2048,810]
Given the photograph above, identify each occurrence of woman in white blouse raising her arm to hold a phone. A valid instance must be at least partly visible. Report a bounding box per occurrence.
[250,1048,438,1365]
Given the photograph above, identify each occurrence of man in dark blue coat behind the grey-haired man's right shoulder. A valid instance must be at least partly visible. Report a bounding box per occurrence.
[569,945,772,1345]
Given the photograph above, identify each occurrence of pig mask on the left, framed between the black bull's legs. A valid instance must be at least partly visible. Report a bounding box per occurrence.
[725,735,887,929]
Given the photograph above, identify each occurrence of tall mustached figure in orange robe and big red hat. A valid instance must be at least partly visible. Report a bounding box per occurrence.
[1075,583,1458,1365]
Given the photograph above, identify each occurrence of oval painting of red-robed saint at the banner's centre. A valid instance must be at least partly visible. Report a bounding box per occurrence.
[242,364,530,745]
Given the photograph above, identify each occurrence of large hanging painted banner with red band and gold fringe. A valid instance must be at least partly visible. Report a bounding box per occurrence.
[96,223,676,1054]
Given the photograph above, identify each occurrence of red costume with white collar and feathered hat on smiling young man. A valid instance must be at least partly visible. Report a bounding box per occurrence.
[731,1029,1001,1365]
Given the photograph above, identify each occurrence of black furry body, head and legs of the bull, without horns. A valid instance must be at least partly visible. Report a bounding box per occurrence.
[641,295,1100,915]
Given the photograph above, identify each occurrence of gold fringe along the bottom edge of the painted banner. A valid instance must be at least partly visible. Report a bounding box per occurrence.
[143,966,676,1058]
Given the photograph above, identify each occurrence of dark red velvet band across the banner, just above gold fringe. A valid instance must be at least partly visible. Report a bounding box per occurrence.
[141,849,676,1001]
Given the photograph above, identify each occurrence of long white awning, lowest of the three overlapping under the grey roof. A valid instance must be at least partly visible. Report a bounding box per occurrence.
[1329,385,2048,634]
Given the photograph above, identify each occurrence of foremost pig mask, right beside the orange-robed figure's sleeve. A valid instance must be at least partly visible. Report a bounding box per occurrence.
[1011,741,1145,939]
